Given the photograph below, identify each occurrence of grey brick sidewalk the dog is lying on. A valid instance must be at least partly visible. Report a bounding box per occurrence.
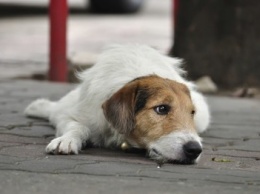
[0,80,260,194]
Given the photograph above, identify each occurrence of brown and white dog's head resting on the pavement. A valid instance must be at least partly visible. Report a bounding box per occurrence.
[102,75,202,163]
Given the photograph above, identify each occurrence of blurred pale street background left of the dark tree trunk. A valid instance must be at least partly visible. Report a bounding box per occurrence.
[0,0,173,78]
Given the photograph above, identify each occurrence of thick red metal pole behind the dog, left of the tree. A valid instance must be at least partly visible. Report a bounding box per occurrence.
[49,0,68,82]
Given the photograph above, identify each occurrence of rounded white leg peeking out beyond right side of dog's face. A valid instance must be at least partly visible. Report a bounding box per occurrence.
[191,91,210,133]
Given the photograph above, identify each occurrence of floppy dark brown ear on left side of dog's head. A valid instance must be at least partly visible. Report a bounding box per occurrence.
[102,83,138,134]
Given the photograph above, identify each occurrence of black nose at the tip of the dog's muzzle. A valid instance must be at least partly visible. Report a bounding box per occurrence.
[183,141,202,160]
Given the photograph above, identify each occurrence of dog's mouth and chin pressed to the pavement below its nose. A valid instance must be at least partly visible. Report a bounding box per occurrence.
[148,148,196,166]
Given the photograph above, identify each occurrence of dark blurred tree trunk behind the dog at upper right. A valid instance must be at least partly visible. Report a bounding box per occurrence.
[170,0,260,87]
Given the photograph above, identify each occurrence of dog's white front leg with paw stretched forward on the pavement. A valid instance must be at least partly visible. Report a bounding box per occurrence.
[46,120,90,154]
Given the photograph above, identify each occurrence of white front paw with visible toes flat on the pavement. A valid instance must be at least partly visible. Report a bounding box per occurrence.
[46,136,82,154]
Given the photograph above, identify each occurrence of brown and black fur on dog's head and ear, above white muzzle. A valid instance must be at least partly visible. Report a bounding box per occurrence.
[103,75,195,148]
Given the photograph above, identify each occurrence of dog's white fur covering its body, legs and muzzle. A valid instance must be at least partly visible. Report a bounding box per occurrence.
[25,45,210,163]
